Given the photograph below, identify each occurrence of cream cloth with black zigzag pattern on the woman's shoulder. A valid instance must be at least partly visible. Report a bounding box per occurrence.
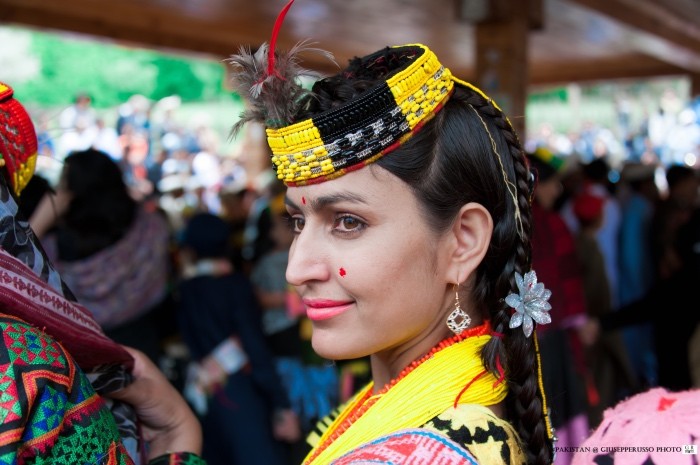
[423,404,526,465]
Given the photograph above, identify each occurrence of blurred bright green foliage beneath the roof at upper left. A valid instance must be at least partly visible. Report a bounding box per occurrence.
[0,27,237,108]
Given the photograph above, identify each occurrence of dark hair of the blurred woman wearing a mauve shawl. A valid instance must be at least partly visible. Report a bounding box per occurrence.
[58,149,136,261]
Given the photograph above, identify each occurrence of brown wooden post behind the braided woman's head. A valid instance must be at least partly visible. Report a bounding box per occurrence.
[475,0,541,143]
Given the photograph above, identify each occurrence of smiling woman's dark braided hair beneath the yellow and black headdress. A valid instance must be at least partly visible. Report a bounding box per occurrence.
[297,62,552,464]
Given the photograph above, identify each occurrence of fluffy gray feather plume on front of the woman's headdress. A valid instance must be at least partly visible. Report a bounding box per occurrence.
[227,41,335,135]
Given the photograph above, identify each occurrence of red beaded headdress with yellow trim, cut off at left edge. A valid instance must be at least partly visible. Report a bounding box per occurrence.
[0,82,37,195]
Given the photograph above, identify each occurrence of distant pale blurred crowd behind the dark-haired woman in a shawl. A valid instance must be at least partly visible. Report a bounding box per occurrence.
[35,94,247,218]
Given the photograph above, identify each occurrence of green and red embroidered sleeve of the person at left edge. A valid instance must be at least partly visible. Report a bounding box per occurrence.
[0,314,204,465]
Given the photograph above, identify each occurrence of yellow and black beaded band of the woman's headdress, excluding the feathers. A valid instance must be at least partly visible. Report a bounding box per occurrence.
[267,44,454,186]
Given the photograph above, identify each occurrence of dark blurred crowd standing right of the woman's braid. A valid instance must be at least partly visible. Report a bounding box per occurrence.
[529,147,700,464]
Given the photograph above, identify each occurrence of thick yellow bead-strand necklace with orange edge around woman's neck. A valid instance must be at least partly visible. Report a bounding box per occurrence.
[304,323,507,465]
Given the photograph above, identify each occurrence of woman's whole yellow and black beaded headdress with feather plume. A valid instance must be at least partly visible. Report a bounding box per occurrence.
[229,1,516,186]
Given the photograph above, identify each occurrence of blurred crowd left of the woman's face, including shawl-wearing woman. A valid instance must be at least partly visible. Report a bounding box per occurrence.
[21,94,348,465]
